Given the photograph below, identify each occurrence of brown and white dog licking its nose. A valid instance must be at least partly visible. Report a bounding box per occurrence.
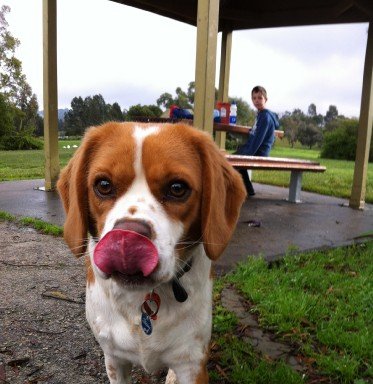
[58,123,245,384]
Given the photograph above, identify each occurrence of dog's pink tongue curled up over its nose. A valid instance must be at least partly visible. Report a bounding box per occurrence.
[93,229,158,277]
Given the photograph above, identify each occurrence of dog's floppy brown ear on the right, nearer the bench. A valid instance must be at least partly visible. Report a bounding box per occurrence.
[193,133,246,260]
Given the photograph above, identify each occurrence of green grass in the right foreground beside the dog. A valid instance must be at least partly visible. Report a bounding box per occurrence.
[212,242,373,384]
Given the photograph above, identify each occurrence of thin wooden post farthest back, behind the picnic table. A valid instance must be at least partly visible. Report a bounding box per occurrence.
[215,31,232,149]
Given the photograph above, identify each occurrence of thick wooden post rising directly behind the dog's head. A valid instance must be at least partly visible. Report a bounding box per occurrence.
[194,0,219,135]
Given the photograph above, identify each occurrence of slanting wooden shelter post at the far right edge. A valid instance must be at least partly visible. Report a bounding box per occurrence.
[349,23,373,209]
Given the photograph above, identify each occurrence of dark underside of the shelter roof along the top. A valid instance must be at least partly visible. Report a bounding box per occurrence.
[111,0,373,31]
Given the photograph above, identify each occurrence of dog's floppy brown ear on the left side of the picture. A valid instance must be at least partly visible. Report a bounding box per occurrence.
[57,130,92,257]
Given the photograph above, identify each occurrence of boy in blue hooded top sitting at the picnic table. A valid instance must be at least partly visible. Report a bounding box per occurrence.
[235,86,280,196]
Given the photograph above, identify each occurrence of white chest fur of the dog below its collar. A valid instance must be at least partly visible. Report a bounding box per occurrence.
[86,245,212,372]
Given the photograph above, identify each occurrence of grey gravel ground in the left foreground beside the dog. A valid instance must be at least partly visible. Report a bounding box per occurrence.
[0,222,164,384]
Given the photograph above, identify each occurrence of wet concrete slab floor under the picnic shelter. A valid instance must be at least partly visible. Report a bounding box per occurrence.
[0,180,373,273]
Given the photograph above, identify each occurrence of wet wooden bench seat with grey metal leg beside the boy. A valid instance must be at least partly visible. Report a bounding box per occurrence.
[225,154,326,203]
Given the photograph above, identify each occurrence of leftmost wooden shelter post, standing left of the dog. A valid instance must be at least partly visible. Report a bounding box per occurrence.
[43,0,60,191]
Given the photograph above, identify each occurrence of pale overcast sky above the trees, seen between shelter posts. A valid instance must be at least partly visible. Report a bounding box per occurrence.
[0,0,368,116]
